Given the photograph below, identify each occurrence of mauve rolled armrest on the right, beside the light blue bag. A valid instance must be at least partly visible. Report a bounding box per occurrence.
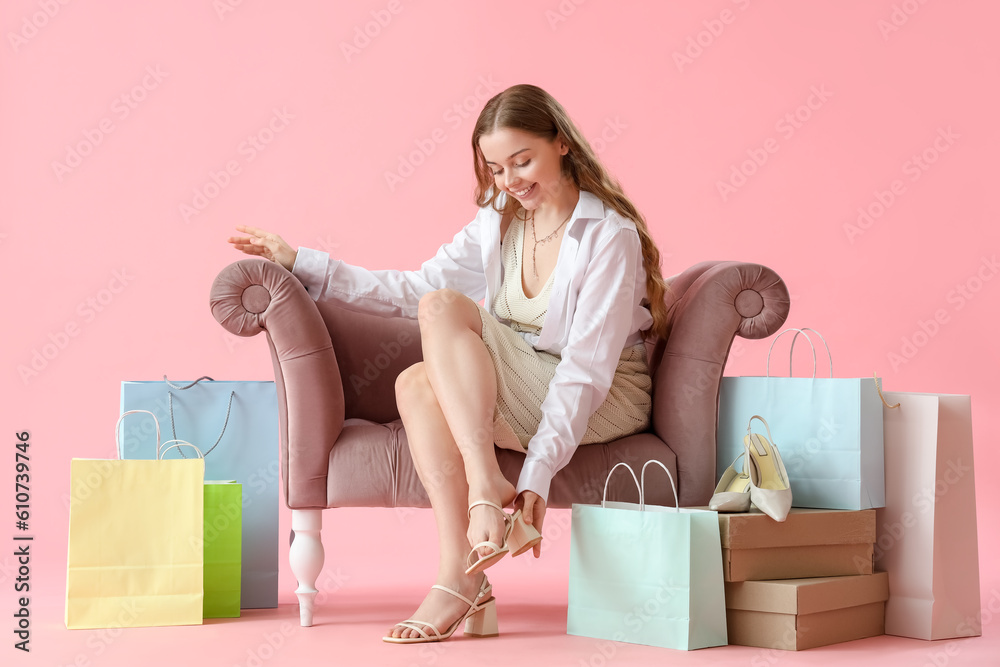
[652,261,790,506]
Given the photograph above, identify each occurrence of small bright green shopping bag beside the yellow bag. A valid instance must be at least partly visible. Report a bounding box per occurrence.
[159,439,243,618]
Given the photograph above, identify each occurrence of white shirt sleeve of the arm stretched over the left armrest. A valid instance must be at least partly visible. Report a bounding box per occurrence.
[292,207,490,318]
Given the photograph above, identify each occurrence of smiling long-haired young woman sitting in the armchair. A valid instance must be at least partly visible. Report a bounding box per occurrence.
[223,84,666,643]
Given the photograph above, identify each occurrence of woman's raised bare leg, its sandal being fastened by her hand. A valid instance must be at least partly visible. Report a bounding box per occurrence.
[418,289,515,556]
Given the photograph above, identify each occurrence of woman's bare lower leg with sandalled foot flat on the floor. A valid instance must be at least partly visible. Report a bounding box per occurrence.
[386,362,484,637]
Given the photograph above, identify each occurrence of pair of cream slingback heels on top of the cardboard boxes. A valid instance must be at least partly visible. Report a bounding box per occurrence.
[708,415,792,521]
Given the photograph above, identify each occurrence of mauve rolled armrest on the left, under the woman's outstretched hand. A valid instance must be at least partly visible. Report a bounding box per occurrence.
[209,259,344,509]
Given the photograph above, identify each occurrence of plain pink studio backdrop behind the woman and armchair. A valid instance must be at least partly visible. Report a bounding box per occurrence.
[0,0,1000,664]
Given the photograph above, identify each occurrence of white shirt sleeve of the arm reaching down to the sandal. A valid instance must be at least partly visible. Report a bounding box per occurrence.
[517,225,644,500]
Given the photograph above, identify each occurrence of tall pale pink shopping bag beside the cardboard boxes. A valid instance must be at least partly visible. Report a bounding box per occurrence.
[875,391,982,639]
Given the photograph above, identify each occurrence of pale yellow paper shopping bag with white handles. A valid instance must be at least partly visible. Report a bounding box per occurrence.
[65,410,205,629]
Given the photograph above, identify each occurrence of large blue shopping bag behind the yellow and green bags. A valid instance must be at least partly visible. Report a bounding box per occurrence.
[121,377,281,609]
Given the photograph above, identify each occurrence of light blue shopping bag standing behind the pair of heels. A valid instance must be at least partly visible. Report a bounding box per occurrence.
[715,328,885,510]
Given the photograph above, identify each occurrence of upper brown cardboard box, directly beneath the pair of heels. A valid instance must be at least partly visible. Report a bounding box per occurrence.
[719,507,875,581]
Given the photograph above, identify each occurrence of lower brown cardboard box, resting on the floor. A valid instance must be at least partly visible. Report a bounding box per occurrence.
[725,572,889,651]
